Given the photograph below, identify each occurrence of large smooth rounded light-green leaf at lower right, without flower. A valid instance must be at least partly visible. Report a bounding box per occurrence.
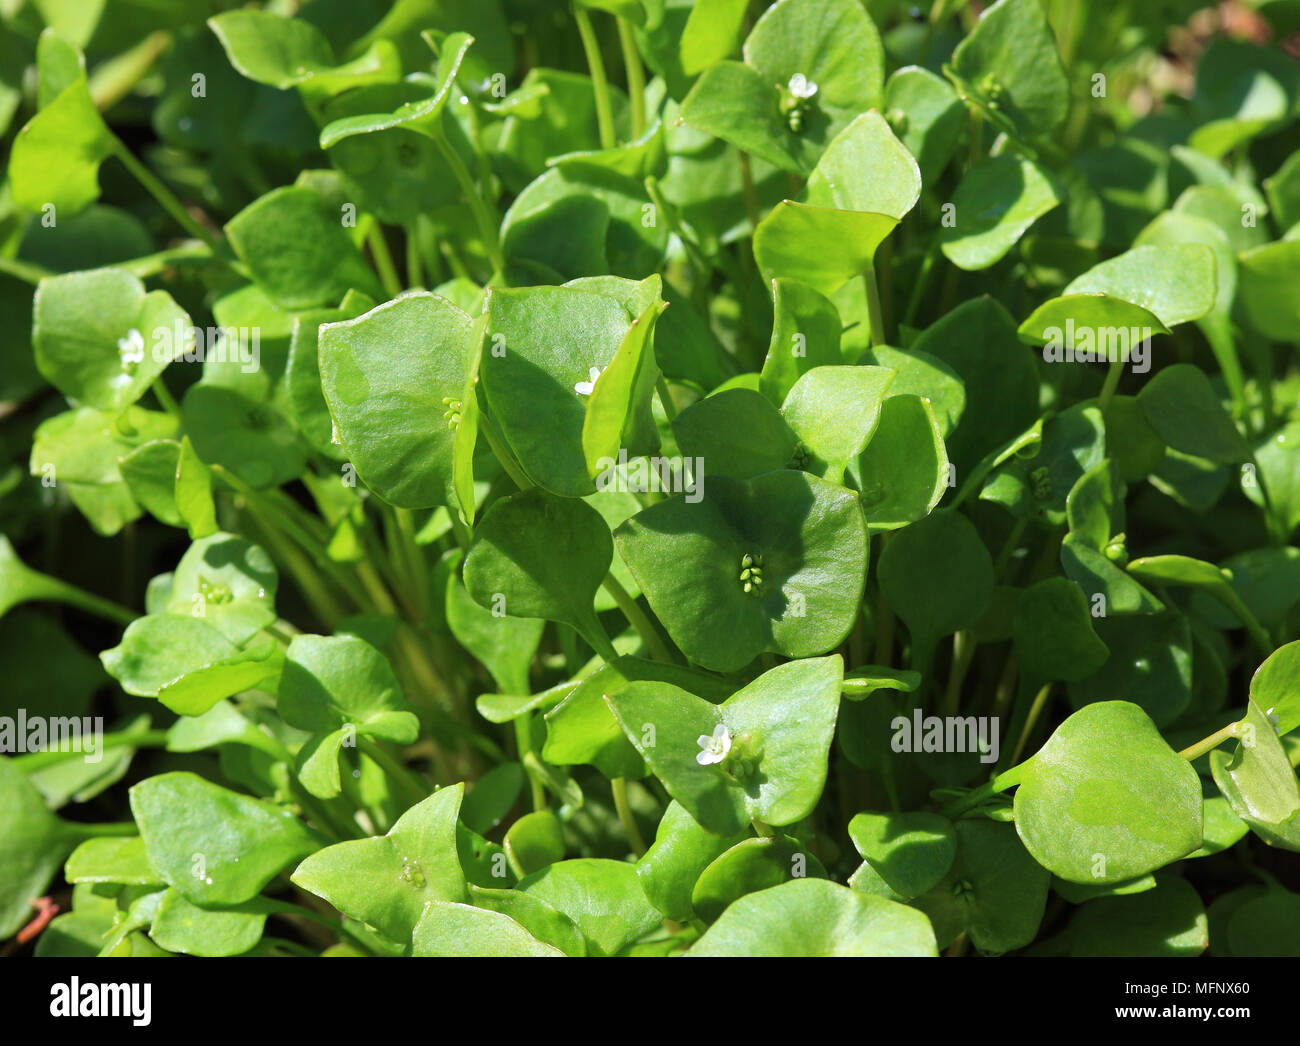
[1014,700,1203,882]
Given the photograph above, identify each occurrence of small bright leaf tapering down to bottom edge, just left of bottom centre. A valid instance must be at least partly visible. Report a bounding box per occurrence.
[515,858,663,955]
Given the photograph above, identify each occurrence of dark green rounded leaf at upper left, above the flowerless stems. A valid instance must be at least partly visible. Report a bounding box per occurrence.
[226,185,385,309]
